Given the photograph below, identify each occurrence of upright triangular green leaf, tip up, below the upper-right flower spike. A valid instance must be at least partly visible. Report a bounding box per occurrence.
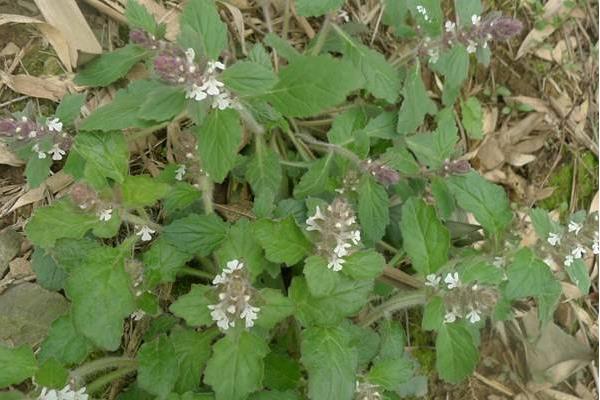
[396,65,437,134]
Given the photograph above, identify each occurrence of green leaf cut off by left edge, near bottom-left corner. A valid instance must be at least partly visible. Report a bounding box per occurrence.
[0,344,37,388]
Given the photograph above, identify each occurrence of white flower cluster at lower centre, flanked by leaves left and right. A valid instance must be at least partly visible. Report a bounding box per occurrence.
[208,260,260,331]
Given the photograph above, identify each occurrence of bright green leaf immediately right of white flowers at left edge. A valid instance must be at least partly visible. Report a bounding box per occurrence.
[73,132,129,183]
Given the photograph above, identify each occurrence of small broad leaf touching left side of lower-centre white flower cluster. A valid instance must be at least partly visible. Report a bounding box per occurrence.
[169,285,216,326]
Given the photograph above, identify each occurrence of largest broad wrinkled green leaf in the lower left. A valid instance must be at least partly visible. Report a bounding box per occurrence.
[66,247,135,351]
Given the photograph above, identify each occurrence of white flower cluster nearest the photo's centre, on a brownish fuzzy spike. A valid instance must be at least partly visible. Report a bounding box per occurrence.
[306,200,360,272]
